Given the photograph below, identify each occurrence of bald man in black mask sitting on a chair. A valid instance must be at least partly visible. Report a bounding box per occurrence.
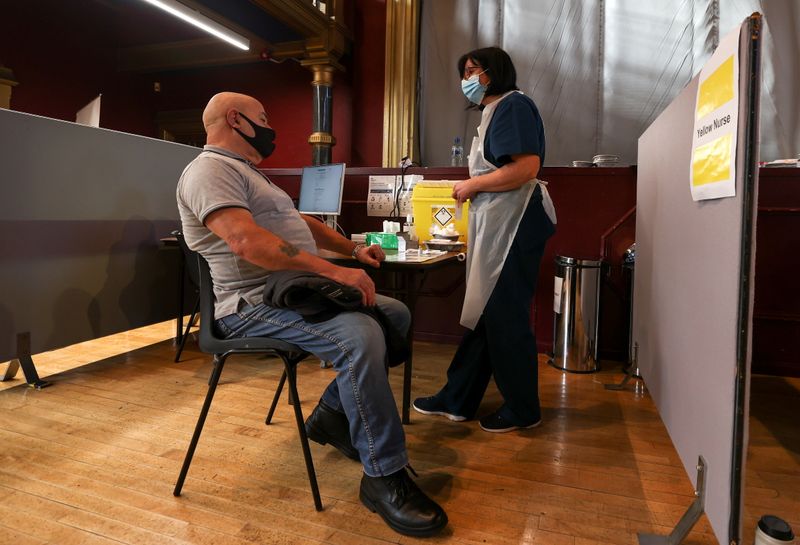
[177,93,447,536]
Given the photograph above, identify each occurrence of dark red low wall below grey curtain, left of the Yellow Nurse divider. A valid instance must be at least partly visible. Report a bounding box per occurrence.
[265,167,636,360]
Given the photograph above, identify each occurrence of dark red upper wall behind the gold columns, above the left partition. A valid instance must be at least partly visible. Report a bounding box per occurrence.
[0,0,386,167]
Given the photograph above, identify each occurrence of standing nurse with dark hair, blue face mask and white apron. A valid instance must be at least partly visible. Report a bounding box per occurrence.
[414,47,556,433]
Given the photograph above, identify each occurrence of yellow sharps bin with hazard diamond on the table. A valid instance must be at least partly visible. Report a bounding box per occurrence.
[411,180,469,243]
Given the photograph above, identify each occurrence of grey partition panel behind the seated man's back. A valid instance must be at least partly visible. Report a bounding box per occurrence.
[0,110,200,361]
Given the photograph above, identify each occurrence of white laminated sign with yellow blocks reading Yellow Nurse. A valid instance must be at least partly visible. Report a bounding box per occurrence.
[689,27,739,201]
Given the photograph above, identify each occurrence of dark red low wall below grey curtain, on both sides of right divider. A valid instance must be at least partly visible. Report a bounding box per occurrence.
[266,167,800,376]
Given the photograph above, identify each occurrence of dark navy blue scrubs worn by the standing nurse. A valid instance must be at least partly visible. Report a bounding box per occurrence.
[436,93,555,426]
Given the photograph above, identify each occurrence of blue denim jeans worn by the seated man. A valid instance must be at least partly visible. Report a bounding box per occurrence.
[217,295,411,477]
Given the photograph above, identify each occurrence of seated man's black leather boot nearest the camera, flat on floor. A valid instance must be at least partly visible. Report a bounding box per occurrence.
[359,468,447,537]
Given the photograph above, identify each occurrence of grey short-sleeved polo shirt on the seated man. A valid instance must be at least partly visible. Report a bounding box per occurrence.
[176,146,317,318]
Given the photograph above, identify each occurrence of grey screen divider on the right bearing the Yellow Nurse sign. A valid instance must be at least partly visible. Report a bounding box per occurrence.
[633,17,760,543]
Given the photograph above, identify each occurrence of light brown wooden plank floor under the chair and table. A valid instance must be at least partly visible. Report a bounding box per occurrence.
[0,324,800,545]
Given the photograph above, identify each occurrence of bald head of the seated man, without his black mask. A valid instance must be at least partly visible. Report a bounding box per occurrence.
[203,92,269,163]
